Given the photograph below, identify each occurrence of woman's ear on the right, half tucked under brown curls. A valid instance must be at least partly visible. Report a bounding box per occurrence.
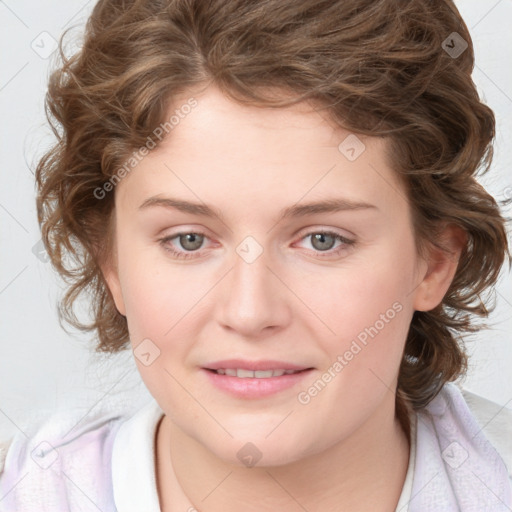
[413,224,467,311]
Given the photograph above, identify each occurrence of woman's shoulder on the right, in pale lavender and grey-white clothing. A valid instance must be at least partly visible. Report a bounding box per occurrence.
[410,382,512,512]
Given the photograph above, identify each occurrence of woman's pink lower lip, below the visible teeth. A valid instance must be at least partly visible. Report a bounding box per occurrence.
[202,368,313,398]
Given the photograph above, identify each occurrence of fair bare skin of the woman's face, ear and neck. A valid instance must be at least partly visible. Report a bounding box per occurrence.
[103,86,463,512]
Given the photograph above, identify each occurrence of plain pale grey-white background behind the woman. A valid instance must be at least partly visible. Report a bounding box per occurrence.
[0,0,512,439]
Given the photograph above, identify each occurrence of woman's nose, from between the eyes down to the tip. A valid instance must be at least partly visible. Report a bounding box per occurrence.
[216,236,287,335]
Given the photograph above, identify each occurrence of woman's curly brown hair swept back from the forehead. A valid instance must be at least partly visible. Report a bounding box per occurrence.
[36,0,510,434]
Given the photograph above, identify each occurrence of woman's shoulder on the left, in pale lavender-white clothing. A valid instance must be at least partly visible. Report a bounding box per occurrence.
[0,404,134,510]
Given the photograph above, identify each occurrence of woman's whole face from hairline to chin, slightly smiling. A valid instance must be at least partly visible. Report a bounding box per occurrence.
[105,87,452,465]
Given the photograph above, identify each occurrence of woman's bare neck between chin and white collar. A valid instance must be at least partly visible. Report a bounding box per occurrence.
[156,396,409,512]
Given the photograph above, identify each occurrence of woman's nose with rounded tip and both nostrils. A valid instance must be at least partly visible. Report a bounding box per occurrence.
[218,241,293,338]
